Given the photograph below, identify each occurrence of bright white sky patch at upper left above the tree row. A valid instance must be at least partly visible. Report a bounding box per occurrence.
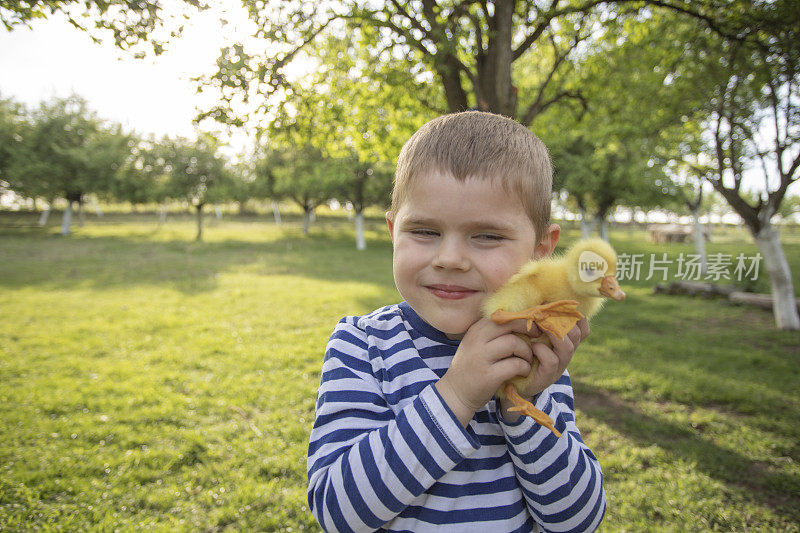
[0,5,253,141]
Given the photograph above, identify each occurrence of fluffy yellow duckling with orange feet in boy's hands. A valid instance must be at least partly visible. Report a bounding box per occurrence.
[483,239,625,437]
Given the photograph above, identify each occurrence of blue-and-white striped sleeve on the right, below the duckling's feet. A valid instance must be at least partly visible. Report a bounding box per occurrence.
[497,372,606,532]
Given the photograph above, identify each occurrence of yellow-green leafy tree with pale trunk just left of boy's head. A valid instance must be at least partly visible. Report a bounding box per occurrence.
[260,36,428,250]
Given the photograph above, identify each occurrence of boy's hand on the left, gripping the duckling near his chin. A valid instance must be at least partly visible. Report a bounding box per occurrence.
[436,318,544,427]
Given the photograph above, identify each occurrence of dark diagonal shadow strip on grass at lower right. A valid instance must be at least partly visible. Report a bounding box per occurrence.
[573,380,800,523]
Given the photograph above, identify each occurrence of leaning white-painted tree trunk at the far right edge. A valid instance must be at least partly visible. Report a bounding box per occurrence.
[755,224,800,330]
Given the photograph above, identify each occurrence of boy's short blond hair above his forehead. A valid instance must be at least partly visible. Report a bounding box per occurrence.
[392,111,553,239]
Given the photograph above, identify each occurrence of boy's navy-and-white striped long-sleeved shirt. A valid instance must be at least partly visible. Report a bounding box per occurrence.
[308,302,606,533]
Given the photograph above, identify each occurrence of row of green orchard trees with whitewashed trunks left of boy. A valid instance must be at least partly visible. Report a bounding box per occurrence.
[0,96,391,244]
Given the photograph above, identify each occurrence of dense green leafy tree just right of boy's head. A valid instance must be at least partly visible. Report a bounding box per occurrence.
[537,12,682,238]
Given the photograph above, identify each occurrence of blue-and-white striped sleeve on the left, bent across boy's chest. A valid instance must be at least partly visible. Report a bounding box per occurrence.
[307,318,479,531]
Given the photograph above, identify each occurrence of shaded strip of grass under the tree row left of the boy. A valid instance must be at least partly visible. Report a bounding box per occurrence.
[0,222,393,293]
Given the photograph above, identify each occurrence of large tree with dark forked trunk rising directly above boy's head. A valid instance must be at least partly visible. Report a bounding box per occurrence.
[200,0,772,132]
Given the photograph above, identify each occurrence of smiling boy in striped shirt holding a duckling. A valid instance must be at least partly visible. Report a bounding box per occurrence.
[308,111,605,533]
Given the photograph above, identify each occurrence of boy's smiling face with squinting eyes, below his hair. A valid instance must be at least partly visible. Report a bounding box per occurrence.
[386,174,559,338]
